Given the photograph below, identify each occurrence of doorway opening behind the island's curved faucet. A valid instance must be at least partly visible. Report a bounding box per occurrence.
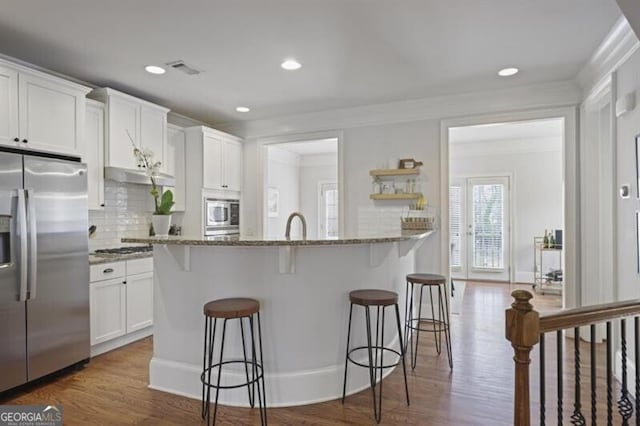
[263,138,340,239]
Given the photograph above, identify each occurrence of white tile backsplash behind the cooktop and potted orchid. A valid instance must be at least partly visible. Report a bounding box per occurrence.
[89,180,153,251]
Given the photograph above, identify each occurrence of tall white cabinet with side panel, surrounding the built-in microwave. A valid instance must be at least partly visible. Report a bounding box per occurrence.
[182,126,242,236]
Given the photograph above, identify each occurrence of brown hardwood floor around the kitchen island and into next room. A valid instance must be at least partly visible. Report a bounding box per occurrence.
[0,283,560,426]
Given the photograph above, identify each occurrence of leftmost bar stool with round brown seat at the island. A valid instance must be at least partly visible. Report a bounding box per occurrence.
[200,298,267,425]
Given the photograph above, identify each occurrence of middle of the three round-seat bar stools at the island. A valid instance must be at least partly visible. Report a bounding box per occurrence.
[342,290,409,423]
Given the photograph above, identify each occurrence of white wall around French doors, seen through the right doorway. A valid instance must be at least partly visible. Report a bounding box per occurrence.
[449,138,564,283]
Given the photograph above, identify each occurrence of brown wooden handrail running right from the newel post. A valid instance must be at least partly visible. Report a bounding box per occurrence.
[544,294,640,333]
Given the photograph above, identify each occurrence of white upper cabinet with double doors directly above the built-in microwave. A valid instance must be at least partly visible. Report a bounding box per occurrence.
[186,126,242,192]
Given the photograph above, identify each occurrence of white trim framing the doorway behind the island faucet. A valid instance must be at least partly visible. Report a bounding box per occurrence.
[256,130,344,236]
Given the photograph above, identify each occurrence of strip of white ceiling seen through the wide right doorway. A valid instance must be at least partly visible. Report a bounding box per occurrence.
[449,118,564,144]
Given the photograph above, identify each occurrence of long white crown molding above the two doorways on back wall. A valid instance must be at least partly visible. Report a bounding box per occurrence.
[216,81,582,139]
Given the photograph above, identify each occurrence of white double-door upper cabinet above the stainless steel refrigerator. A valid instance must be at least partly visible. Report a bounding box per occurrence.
[0,60,90,158]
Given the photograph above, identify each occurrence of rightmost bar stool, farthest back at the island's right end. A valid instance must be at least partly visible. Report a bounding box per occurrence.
[404,274,453,369]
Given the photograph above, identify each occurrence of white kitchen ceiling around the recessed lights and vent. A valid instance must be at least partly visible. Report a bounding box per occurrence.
[0,0,620,123]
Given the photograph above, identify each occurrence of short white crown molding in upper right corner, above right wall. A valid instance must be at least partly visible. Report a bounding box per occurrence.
[577,16,640,95]
